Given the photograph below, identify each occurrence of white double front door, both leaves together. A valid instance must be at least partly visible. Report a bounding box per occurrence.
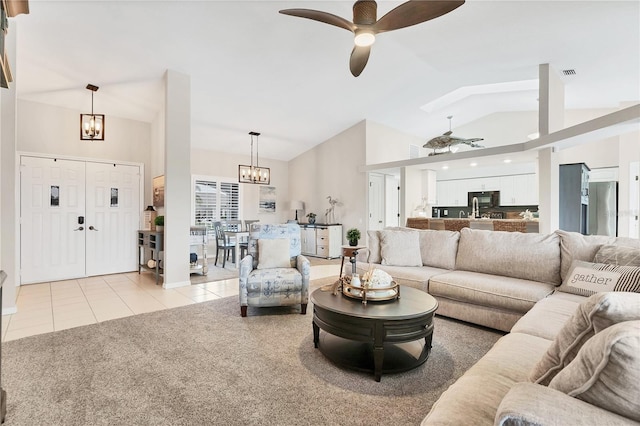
[20,156,141,284]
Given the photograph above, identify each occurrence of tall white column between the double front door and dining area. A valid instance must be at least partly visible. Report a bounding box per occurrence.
[163,70,191,288]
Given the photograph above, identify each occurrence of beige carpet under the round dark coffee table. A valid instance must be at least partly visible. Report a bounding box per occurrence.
[2,278,502,426]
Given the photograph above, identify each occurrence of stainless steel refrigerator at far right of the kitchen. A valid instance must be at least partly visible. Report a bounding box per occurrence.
[588,182,618,237]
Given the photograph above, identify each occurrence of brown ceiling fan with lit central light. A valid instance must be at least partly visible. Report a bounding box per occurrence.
[280,0,464,77]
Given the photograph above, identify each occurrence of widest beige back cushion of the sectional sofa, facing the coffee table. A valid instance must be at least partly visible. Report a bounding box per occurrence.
[456,228,561,284]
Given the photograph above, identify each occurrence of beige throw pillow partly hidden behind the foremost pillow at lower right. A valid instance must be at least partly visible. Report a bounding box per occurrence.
[529,292,640,386]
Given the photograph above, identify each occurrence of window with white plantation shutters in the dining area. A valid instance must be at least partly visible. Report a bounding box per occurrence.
[194,179,240,229]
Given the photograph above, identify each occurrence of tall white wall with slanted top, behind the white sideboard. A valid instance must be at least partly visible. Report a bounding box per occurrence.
[289,121,368,242]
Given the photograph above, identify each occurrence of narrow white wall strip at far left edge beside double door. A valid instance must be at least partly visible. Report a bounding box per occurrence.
[0,25,20,315]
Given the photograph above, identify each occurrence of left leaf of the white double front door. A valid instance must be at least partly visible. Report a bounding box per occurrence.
[20,157,86,283]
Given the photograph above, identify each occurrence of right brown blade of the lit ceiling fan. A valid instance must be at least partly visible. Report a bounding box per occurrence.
[373,0,464,33]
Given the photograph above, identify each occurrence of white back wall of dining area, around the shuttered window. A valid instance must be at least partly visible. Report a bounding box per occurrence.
[191,148,290,223]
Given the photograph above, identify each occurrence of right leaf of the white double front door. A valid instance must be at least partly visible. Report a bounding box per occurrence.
[86,163,141,276]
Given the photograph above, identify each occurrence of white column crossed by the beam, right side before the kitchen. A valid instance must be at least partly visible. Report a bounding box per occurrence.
[538,64,564,233]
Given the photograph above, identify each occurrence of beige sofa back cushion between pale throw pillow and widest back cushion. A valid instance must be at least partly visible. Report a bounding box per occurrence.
[417,230,460,269]
